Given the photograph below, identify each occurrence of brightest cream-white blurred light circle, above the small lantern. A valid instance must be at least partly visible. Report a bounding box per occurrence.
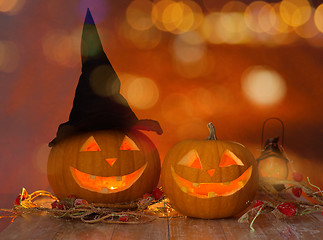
[241,66,286,105]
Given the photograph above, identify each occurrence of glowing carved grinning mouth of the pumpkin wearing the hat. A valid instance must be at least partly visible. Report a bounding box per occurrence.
[70,163,147,194]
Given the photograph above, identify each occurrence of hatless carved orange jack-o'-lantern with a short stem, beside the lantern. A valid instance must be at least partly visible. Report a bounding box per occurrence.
[161,124,258,218]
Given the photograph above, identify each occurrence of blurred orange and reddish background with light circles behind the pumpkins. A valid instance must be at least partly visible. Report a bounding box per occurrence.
[0,0,323,232]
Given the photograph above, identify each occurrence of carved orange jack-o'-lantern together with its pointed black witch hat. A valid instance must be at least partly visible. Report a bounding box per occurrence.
[47,10,162,203]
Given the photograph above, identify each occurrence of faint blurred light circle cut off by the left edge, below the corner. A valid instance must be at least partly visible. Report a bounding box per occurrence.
[0,41,20,73]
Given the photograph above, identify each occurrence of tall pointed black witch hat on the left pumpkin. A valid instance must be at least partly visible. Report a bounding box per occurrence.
[49,9,162,146]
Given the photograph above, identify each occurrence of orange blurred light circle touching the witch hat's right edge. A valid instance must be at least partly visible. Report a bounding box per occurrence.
[119,73,159,109]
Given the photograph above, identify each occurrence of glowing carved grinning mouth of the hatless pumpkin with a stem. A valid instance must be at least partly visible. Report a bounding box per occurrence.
[171,166,252,198]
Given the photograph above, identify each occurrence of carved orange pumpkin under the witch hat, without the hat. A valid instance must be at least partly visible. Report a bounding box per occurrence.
[48,130,160,203]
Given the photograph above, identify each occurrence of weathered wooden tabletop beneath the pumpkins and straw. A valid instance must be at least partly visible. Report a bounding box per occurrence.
[0,209,323,240]
